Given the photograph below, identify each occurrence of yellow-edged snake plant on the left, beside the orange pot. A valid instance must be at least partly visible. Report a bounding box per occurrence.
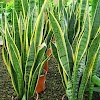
[0,0,50,100]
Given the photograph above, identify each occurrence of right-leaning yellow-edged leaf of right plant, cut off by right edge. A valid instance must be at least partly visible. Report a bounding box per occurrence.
[78,34,100,100]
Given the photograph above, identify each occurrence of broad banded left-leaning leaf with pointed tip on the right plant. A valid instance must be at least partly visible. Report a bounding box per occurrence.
[50,13,70,76]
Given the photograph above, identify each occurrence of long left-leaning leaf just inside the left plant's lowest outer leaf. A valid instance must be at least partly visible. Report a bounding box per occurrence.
[5,20,24,96]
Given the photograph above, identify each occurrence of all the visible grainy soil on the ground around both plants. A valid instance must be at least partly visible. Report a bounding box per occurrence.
[0,47,100,100]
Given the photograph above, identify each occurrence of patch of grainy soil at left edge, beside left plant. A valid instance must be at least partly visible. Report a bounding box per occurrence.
[0,46,14,100]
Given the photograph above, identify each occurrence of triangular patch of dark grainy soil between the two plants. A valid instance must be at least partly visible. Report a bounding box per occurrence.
[39,58,65,100]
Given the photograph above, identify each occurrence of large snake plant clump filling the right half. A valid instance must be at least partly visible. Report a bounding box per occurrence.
[49,0,100,100]
